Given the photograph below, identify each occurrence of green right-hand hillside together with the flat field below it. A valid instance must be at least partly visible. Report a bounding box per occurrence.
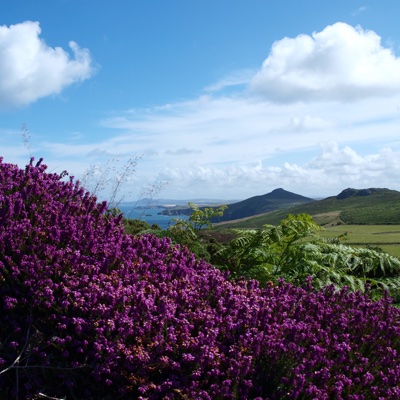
[212,189,400,258]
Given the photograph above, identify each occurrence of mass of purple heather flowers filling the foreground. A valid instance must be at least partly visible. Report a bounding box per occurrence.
[0,160,400,400]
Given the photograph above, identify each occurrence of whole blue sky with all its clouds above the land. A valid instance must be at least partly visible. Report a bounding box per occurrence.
[0,0,400,200]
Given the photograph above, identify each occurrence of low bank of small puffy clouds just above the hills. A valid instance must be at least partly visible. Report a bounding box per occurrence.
[155,142,400,198]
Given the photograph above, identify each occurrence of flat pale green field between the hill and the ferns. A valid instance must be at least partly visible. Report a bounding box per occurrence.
[320,225,400,257]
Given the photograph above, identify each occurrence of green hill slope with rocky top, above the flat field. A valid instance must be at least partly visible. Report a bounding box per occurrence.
[218,188,400,228]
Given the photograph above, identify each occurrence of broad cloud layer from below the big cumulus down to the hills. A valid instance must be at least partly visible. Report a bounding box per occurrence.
[30,82,400,199]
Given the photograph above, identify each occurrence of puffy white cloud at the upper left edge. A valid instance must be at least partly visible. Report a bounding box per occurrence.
[0,21,95,107]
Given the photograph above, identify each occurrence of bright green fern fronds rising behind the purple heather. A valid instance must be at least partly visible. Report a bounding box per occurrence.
[216,214,400,302]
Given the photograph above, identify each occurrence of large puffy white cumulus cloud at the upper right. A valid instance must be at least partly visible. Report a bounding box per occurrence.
[249,22,400,103]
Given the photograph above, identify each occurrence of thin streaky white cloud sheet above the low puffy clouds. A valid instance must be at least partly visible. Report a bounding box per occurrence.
[102,91,400,165]
